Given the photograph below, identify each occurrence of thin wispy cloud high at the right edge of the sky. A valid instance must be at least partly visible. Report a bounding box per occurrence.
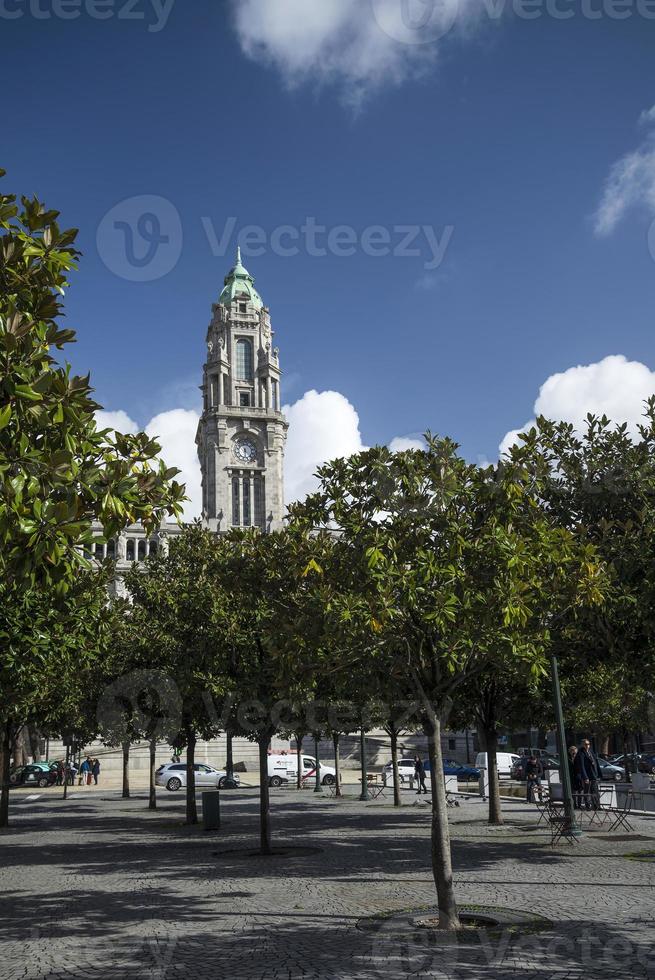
[594,106,655,236]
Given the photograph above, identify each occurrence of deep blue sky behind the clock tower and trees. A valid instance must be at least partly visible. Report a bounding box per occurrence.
[0,0,655,512]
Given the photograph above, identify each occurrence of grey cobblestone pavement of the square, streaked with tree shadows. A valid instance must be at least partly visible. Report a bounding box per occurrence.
[0,790,655,980]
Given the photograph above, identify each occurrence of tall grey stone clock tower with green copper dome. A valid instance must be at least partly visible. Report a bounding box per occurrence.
[196,249,288,532]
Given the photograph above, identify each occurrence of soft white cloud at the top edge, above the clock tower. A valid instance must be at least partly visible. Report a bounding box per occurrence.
[232,0,468,105]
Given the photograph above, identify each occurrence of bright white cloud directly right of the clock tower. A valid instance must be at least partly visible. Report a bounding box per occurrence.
[282,390,366,503]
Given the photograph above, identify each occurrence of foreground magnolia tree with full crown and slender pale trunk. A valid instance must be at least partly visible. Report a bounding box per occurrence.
[292,435,597,929]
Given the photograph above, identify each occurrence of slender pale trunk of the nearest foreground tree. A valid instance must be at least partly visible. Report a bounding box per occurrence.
[427,711,460,930]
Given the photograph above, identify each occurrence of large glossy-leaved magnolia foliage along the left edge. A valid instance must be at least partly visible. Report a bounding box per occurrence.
[0,171,183,822]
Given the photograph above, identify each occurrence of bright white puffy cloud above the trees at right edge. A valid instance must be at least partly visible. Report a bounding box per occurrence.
[499,354,655,455]
